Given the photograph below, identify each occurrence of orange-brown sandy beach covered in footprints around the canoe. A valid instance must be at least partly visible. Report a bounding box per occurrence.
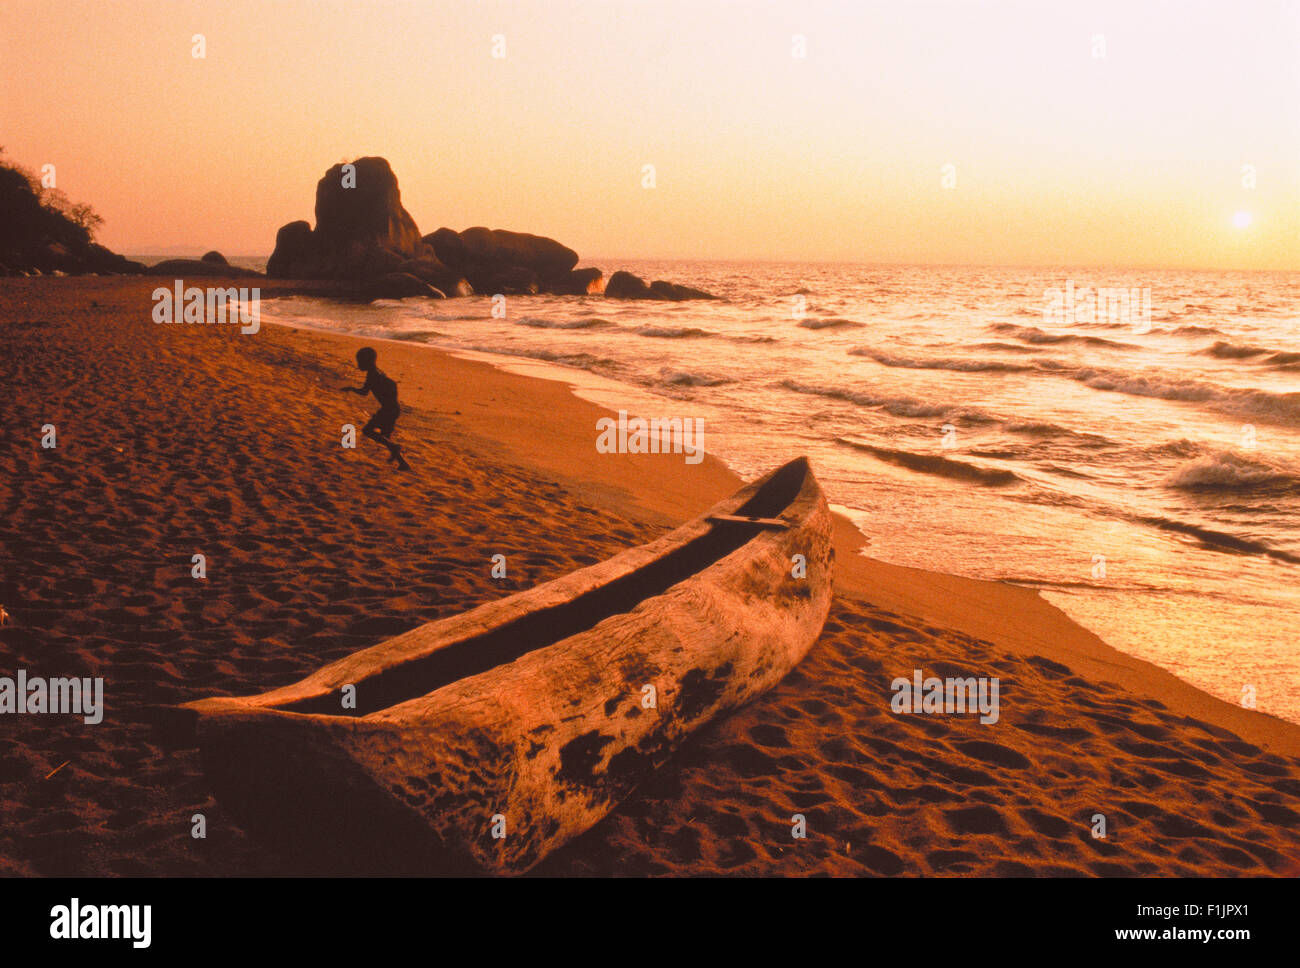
[0,278,1300,876]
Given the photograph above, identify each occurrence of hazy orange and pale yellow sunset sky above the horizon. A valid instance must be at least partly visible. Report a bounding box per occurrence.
[0,0,1300,269]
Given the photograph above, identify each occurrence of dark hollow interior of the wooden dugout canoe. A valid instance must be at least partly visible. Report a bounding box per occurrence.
[276,460,810,717]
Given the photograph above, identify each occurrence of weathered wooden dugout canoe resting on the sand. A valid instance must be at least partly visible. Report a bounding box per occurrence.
[170,457,833,873]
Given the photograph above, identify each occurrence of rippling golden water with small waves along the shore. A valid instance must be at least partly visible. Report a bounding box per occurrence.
[263,260,1300,722]
